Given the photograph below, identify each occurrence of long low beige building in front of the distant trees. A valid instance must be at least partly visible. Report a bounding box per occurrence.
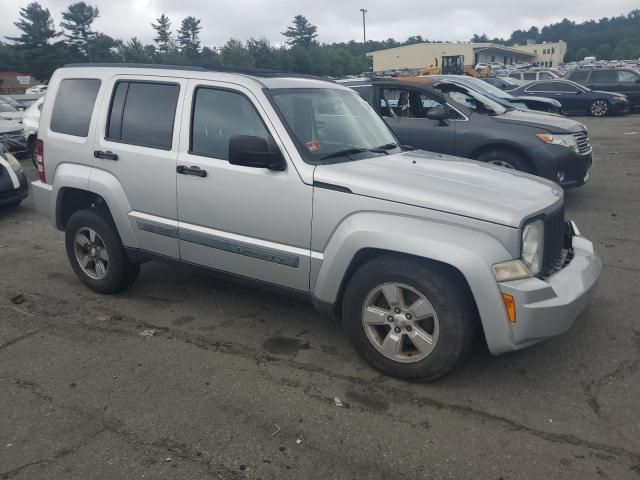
[367,43,536,72]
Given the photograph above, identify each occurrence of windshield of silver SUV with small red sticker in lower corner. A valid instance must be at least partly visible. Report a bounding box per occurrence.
[269,88,399,165]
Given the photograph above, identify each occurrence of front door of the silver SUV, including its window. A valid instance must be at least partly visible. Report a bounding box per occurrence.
[177,80,313,292]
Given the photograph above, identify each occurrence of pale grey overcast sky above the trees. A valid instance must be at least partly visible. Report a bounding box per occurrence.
[0,0,639,46]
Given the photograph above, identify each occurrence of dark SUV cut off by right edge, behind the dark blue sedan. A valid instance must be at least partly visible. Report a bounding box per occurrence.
[567,68,640,109]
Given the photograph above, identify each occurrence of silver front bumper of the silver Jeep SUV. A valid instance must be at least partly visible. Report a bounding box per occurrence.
[499,229,602,350]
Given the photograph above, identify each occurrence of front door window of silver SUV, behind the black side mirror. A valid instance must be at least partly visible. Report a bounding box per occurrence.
[190,88,270,160]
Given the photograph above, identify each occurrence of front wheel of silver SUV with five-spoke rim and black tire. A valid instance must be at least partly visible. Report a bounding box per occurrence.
[342,255,476,381]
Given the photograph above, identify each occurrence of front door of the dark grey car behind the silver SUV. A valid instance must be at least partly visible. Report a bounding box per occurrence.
[374,85,456,155]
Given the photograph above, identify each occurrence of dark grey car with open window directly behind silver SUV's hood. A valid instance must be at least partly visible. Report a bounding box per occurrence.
[345,79,591,188]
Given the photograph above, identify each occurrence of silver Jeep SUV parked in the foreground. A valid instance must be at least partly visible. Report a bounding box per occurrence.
[28,65,600,380]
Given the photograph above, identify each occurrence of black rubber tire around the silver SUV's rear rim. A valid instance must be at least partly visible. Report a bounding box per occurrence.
[65,208,140,294]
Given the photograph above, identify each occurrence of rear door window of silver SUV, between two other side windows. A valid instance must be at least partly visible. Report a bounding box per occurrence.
[106,81,180,150]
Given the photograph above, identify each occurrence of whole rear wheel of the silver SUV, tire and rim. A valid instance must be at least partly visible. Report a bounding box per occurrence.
[65,208,140,294]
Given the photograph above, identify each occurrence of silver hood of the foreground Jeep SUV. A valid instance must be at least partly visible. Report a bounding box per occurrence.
[314,150,563,227]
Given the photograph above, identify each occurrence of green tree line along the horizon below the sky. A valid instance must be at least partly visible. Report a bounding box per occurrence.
[0,1,640,80]
